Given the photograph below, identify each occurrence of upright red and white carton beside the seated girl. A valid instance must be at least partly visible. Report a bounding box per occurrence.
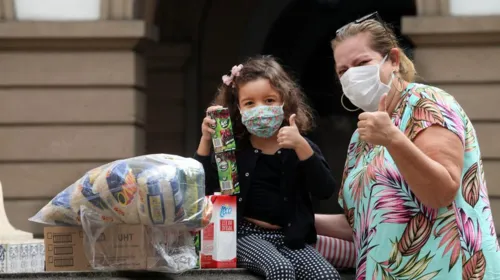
[200,194,237,268]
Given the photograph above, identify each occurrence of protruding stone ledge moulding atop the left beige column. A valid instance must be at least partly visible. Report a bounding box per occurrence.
[0,20,158,51]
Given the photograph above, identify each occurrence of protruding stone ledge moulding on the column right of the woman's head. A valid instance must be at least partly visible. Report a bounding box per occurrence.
[401,16,500,47]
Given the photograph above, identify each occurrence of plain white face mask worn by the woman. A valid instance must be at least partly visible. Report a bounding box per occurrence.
[340,55,394,112]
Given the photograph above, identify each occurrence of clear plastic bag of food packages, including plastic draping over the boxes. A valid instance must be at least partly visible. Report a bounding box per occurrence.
[30,154,212,272]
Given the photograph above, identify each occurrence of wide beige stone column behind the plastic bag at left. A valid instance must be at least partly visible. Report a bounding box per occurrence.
[0,0,156,234]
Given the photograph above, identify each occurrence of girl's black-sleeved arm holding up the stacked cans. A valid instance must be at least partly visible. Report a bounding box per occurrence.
[193,139,219,195]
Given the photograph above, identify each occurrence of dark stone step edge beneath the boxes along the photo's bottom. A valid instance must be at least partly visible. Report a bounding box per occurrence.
[0,269,354,280]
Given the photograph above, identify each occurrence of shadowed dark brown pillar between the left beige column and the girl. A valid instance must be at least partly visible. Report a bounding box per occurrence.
[146,42,192,156]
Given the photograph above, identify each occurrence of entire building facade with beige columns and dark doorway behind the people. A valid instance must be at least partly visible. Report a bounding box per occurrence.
[0,0,500,237]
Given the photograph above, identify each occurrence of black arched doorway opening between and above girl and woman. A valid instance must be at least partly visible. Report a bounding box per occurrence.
[243,0,416,213]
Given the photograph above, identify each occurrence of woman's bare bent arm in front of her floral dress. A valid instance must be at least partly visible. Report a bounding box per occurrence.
[386,125,464,208]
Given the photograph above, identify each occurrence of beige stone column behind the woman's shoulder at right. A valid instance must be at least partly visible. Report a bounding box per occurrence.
[402,0,500,233]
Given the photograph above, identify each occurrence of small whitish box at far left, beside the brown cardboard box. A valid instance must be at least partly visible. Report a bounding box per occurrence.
[0,239,45,273]
